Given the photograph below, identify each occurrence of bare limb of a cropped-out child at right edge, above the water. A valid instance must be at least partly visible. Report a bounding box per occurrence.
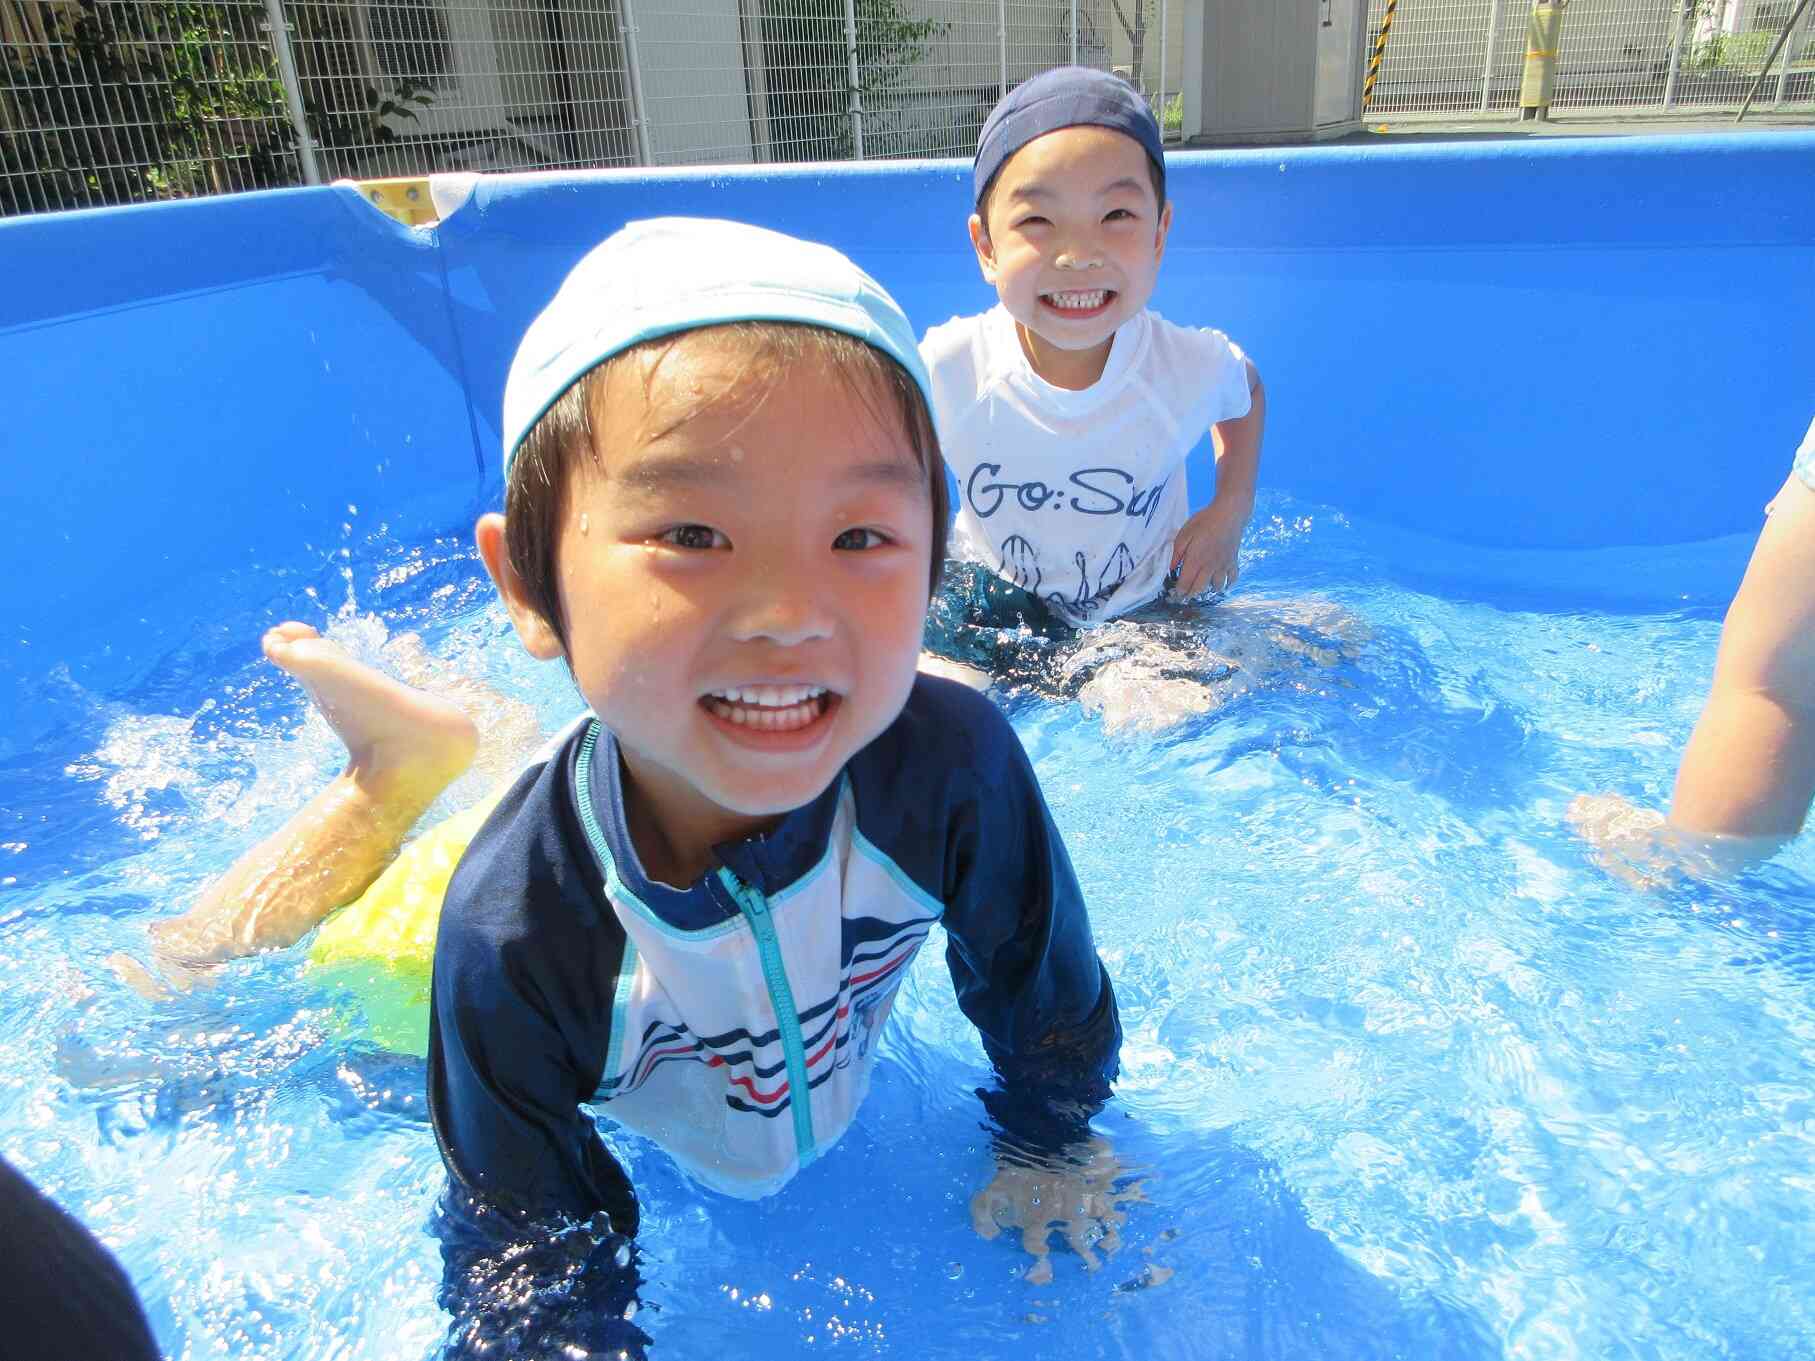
[1670,477,1815,837]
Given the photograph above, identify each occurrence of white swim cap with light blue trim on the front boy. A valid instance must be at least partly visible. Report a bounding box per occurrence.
[505,218,933,475]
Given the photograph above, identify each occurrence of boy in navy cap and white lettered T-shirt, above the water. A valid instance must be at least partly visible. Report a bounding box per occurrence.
[920,67,1265,682]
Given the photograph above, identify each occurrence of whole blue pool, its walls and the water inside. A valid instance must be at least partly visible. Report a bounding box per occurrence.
[0,132,1815,1361]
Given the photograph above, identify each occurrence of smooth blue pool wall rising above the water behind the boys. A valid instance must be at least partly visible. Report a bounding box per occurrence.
[0,131,1815,735]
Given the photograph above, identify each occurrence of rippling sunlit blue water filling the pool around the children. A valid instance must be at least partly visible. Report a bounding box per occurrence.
[0,495,1815,1361]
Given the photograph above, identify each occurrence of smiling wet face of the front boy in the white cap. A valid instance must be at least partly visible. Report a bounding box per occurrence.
[479,328,933,882]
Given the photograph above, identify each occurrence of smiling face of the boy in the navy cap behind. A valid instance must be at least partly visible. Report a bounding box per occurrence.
[971,127,1172,388]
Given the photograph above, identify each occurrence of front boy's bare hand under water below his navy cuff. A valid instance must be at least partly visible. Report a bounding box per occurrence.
[971,1138,1143,1285]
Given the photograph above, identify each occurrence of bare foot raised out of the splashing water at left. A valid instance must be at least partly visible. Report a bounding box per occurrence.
[263,622,479,795]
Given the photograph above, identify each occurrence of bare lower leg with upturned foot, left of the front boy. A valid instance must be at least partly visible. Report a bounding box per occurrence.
[125,624,479,982]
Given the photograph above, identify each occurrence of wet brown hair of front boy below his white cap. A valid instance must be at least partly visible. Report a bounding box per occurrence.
[505,321,951,651]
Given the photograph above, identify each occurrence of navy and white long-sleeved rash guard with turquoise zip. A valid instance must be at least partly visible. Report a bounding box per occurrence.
[428,677,1122,1356]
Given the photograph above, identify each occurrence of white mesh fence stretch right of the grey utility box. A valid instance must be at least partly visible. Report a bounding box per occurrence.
[1369,0,1815,114]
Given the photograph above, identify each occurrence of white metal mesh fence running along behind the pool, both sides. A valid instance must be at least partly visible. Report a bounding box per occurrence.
[10,0,1815,214]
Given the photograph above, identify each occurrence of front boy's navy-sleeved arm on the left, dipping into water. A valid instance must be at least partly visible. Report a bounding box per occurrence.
[428,776,646,1357]
